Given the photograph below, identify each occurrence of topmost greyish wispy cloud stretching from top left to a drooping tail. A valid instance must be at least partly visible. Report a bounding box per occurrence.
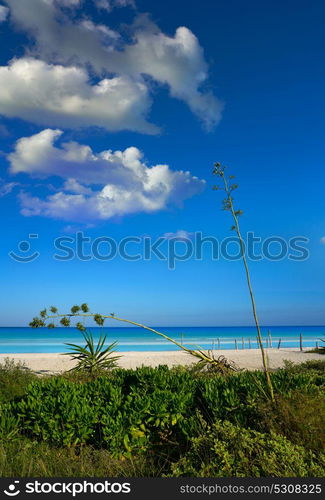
[0,0,223,128]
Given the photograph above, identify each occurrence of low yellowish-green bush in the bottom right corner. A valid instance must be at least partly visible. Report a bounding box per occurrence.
[172,421,325,477]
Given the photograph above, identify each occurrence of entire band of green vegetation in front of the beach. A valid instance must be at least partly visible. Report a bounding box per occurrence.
[0,361,325,477]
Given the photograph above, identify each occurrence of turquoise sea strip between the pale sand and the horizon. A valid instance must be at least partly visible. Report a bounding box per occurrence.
[0,326,325,353]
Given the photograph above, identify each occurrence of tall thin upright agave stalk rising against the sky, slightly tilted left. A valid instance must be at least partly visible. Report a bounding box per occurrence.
[213,163,274,401]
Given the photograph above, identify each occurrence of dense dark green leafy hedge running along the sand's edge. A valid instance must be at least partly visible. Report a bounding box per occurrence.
[4,366,324,459]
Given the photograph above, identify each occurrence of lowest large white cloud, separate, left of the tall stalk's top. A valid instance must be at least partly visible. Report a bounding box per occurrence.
[8,129,205,222]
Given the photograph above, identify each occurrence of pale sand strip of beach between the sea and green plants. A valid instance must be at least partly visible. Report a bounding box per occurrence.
[0,348,325,374]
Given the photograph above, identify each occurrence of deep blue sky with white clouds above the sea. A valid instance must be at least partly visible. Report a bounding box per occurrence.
[0,0,325,326]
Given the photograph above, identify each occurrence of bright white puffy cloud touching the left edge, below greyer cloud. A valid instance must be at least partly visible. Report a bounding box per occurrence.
[0,58,157,133]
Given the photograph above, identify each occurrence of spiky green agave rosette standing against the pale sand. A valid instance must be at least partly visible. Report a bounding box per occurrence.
[63,331,121,375]
